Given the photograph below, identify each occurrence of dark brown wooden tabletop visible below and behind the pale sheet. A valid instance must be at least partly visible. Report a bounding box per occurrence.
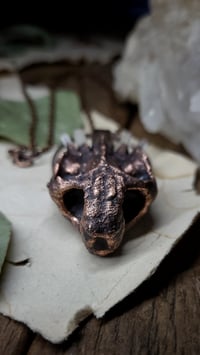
[0,64,200,355]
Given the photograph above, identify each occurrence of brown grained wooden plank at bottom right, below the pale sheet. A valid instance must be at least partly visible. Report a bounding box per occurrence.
[28,254,200,355]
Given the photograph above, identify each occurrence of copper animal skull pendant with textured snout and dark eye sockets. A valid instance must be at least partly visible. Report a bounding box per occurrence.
[48,130,157,256]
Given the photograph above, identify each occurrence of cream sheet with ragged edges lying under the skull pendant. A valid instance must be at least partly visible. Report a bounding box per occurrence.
[0,113,200,343]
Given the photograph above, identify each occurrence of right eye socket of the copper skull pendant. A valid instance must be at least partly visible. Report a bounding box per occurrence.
[122,189,146,223]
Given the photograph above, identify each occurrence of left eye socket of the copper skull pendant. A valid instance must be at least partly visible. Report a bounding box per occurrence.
[63,189,84,219]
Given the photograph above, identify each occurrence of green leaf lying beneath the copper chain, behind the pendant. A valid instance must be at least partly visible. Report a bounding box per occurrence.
[0,90,82,148]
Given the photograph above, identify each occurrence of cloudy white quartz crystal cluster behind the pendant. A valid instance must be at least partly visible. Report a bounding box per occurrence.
[114,0,200,161]
